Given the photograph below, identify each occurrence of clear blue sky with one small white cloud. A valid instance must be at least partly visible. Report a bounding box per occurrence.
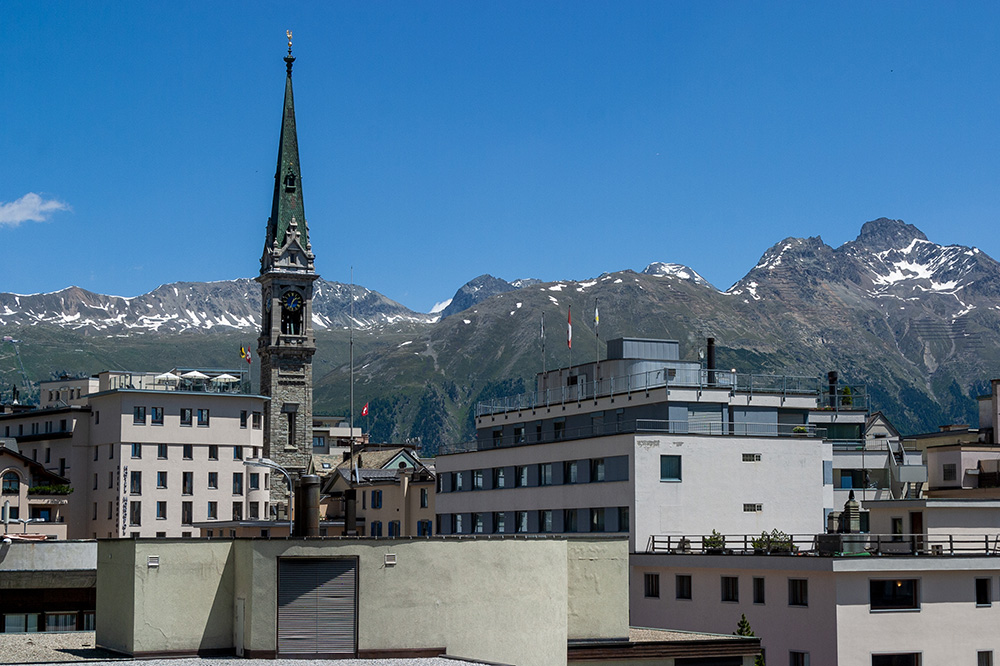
[0,0,1000,311]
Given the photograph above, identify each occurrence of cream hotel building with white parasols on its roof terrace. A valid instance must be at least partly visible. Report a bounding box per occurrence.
[0,369,270,539]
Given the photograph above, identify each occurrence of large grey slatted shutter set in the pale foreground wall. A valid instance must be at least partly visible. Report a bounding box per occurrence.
[278,557,358,657]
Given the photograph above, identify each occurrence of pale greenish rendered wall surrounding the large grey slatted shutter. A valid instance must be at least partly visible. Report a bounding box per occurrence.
[97,539,628,666]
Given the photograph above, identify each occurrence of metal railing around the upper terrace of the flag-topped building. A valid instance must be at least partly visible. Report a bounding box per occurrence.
[475,368,869,417]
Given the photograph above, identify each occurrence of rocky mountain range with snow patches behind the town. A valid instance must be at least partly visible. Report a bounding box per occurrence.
[0,218,1000,452]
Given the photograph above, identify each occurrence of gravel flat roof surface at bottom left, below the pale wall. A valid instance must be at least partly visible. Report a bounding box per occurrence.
[0,631,475,666]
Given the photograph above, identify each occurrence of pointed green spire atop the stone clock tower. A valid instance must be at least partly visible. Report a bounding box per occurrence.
[265,32,309,252]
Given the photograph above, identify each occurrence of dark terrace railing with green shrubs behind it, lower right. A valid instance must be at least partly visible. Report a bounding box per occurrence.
[646,533,1000,557]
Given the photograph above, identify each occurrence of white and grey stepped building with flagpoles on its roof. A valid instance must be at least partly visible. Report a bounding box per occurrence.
[436,338,885,550]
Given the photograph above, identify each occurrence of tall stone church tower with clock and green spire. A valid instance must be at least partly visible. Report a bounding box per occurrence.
[257,33,319,510]
